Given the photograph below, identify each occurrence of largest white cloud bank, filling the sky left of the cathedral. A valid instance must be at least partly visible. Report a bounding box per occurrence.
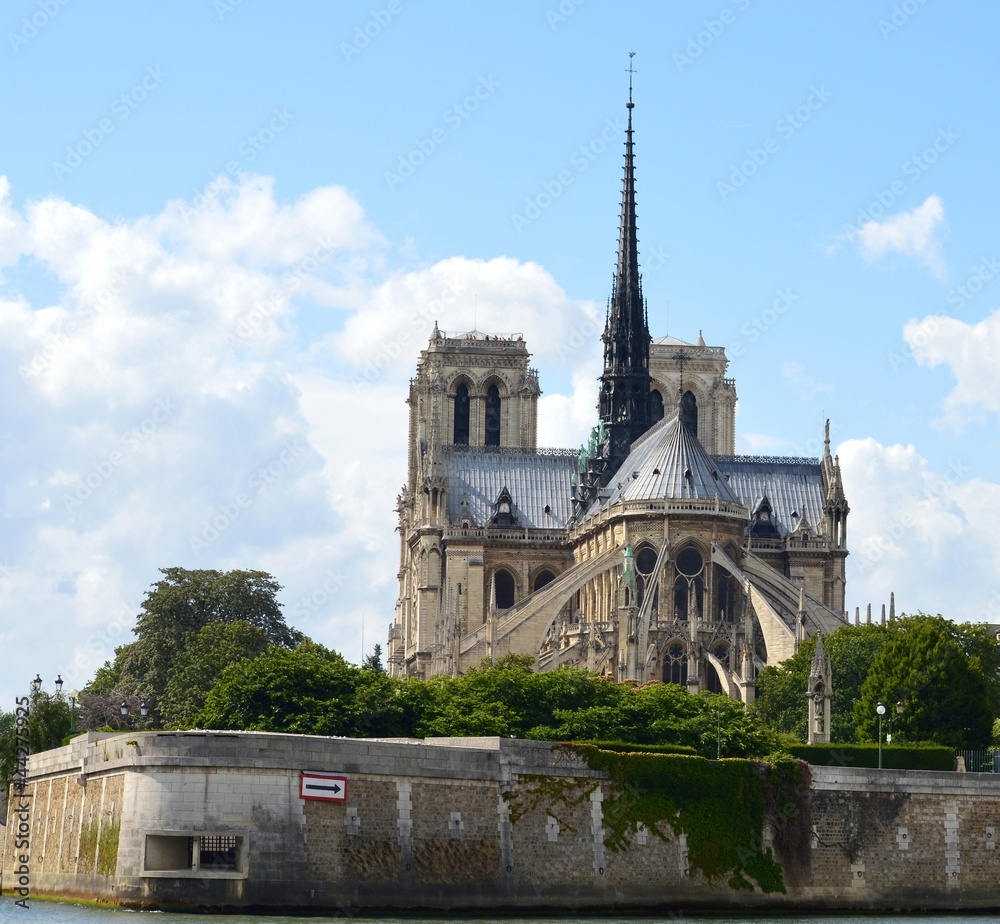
[0,176,600,700]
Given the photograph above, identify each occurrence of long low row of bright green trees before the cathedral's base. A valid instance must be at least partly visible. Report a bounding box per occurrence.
[195,643,778,757]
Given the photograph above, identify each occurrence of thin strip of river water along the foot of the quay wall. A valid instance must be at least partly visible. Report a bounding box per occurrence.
[0,908,998,924]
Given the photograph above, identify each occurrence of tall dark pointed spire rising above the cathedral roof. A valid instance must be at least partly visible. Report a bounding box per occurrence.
[598,52,650,477]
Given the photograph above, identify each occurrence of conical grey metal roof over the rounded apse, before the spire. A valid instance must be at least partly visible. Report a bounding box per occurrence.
[608,415,740,504]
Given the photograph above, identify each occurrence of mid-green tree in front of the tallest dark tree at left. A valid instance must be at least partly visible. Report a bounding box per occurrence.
[159,619,271,728]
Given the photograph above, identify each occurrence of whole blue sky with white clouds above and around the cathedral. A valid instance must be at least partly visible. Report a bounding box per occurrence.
[0,0,1000,702]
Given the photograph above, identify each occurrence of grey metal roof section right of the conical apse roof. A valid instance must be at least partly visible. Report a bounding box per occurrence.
[713,456,824,536]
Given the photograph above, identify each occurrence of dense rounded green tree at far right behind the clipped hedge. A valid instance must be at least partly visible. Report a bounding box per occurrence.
[854,613,994,748]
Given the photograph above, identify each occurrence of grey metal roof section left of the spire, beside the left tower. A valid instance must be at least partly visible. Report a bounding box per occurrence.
[444,446,577,529]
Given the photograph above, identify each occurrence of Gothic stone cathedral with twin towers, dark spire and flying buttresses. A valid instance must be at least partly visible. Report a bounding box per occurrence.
[387,83,849,702]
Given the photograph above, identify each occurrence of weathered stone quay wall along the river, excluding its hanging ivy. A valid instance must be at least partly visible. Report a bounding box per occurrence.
[0,731,1000,915]
